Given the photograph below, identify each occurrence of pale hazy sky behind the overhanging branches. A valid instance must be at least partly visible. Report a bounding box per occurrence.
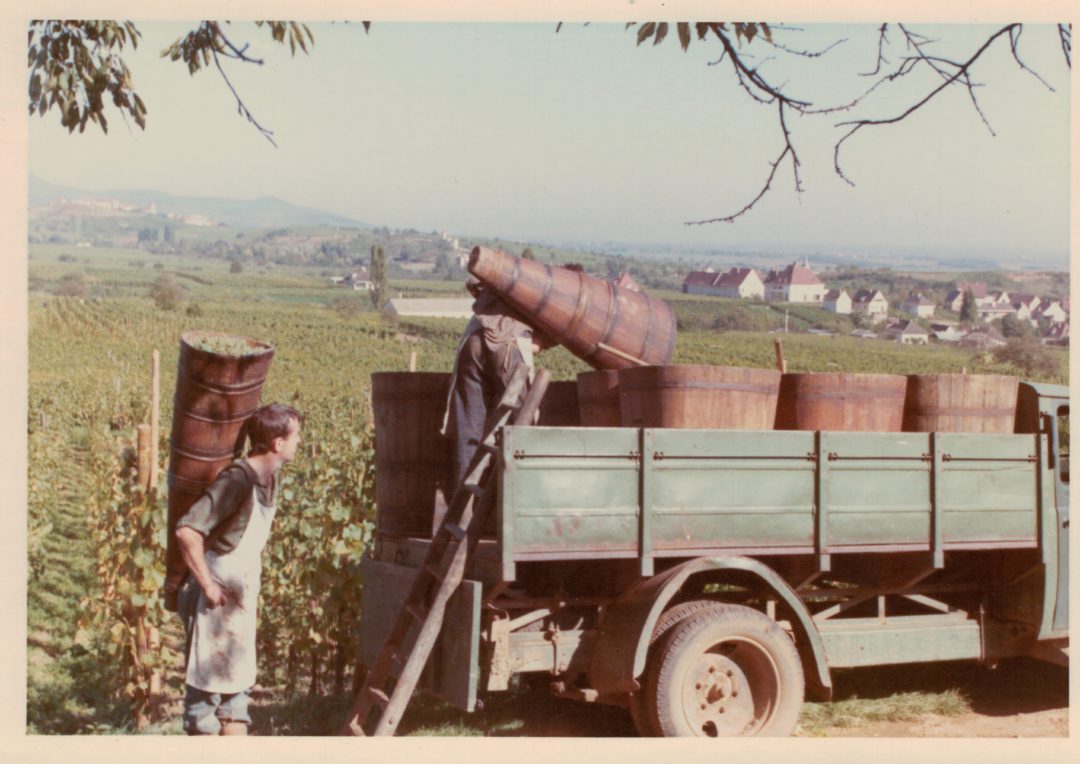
[27,21,1070,267]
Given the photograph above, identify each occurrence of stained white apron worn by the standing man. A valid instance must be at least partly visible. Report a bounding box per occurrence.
[186,487,274,693]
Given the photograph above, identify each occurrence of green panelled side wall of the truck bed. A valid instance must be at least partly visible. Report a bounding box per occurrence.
[496,427,1052,581]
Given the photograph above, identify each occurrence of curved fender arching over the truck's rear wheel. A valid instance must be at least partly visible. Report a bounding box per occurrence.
[589,557,833,699]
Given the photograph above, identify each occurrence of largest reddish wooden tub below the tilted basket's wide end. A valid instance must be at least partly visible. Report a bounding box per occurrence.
[619,365,781,430]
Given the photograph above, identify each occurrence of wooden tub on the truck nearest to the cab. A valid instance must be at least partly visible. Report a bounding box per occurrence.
[904,374,1020,433]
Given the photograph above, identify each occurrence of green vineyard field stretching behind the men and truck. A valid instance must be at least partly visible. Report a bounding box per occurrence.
[27,246,1067,735]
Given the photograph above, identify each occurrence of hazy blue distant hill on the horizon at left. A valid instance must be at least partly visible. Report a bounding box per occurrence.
[29,175,373,228]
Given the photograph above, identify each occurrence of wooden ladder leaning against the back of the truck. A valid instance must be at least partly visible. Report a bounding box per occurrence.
[341,366,551,737]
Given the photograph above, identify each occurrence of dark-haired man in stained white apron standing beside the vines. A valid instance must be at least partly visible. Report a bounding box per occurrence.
[176,403,300,735]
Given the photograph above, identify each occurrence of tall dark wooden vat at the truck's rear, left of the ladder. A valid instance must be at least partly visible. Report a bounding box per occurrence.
[372,372,451,538]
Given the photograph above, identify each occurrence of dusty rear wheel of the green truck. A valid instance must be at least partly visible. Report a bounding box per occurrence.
[645,605,804,737]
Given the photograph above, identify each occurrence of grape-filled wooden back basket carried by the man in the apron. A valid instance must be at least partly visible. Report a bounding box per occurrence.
[165,331,273,607]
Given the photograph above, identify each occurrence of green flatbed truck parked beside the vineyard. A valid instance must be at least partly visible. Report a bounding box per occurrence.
[360,384,1069,736]
